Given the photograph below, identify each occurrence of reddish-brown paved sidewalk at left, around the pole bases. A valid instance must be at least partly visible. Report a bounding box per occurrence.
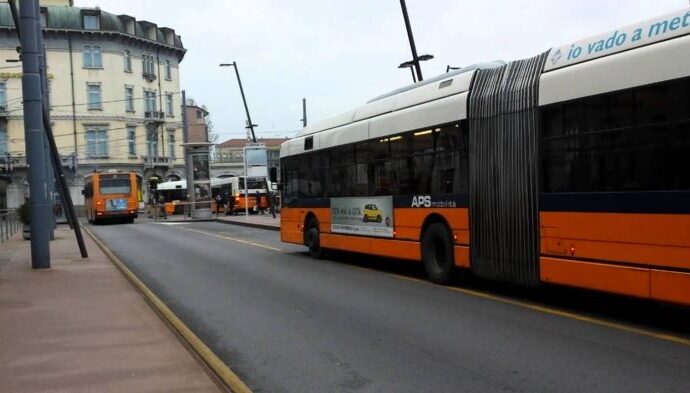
[0,226,221,393]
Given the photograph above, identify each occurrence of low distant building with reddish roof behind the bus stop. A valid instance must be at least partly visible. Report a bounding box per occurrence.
[211,138,288,177]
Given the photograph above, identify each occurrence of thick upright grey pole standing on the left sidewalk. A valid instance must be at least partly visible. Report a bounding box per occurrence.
[18,0,52,269]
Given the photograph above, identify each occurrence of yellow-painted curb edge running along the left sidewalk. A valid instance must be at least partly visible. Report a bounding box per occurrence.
[82,227,252,393]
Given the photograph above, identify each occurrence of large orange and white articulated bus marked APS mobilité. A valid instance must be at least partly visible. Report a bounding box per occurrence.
[280,9,690,305]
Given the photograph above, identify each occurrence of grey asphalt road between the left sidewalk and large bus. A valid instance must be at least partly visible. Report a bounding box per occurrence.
[86,223,690,393]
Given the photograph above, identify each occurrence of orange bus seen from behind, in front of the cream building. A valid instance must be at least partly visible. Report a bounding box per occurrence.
[82,172,139,223]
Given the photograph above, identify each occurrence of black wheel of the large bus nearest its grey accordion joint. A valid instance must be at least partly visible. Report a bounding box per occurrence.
[422,222,455,284]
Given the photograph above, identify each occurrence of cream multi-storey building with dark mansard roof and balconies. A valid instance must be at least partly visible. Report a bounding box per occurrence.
[0,0,185,207]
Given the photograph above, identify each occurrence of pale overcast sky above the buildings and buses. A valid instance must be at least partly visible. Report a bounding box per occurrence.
[75,0,688,141]
